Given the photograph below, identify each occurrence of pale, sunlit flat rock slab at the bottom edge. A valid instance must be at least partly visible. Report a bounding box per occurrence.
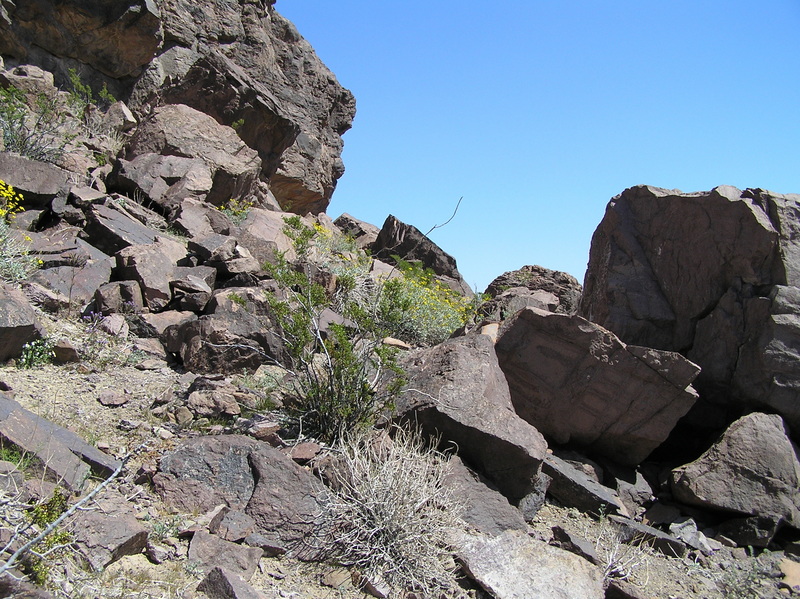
[456,531,605,599]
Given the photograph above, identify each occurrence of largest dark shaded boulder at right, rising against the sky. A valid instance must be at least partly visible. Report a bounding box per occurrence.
[580,186,800,429]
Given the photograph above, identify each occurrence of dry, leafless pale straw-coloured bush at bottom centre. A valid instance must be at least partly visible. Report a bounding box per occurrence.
[311,429,462,597]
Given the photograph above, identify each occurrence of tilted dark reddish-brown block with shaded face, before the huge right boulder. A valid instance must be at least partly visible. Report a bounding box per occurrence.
[496,308,698,465]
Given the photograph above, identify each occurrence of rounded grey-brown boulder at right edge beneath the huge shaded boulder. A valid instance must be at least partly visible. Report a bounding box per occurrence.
[671,413,800,527]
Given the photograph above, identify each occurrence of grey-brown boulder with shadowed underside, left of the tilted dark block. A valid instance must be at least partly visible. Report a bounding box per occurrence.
[397,335,547,501]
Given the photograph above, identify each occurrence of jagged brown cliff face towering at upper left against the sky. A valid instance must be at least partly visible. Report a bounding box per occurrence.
[0,0,355,214]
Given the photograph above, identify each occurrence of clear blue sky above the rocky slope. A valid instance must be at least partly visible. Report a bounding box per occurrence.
[275,0,800,290]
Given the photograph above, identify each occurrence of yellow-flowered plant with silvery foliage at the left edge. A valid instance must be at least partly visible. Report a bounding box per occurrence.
[0,180,42,282]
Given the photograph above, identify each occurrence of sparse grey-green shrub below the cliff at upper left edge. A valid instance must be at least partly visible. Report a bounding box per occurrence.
[0,87,75,162]
